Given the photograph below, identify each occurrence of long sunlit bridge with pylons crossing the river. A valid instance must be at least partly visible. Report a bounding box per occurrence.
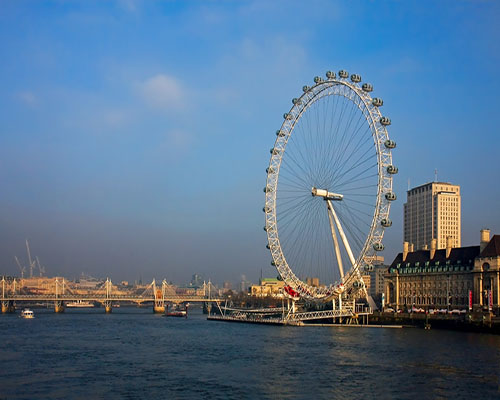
[0,277,222,313]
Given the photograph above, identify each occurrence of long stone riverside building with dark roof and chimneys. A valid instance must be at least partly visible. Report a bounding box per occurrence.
[385,230,500,314]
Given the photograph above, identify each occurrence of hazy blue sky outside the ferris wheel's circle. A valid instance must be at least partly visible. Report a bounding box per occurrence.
[0,0,500,283]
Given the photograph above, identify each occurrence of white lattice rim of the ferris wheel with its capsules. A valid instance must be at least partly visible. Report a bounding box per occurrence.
[264,71,397,299]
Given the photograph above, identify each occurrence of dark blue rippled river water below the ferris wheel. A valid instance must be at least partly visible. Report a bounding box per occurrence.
[0,307,500,400]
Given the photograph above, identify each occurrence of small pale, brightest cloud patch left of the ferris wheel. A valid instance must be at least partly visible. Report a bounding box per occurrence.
[139,74,186,111]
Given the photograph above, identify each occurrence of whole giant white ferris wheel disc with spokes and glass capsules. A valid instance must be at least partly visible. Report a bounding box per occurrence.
[263,70,398,300]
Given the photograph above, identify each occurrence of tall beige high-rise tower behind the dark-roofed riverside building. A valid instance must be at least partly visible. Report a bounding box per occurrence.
[404,182,461,250]
